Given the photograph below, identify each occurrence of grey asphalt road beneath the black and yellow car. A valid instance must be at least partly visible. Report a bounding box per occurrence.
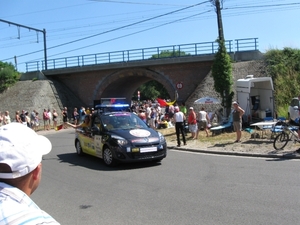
[32,129,300,225]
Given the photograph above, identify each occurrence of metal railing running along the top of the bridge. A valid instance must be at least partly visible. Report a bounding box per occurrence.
[26,38,258,72]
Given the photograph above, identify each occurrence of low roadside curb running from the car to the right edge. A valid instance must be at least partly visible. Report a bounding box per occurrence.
[168,146,300,159]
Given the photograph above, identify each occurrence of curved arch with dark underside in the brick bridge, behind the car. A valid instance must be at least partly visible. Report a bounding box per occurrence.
[93,68,176,102]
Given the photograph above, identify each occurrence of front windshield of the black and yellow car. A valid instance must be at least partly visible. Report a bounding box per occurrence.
[101,113,148,130]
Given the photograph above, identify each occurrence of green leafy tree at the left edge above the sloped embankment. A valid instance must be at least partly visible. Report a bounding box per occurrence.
[0,62,20,92]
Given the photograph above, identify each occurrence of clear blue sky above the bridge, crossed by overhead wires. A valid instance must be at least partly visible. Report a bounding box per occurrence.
[0,0,300,72]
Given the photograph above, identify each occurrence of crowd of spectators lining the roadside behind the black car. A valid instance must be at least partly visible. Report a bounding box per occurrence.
[0,100,216,134]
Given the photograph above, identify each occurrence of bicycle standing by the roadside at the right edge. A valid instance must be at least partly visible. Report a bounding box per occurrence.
[273,121,300,150]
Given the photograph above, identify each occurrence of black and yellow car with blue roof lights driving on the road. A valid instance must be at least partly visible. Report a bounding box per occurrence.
[75,112,167,166]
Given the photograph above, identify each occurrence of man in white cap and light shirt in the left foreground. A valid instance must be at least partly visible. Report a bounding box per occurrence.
[0,123,59,225]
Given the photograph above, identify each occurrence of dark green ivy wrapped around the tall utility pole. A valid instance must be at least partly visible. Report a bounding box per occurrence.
[212,40,234,115]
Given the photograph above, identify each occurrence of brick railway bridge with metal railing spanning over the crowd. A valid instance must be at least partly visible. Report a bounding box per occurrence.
[22,38,262,106]
